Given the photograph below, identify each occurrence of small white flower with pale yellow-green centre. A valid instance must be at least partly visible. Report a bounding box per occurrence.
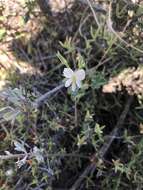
[63,68,85,92]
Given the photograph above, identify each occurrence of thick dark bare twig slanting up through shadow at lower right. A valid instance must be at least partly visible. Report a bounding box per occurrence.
[70,97,133,190]
